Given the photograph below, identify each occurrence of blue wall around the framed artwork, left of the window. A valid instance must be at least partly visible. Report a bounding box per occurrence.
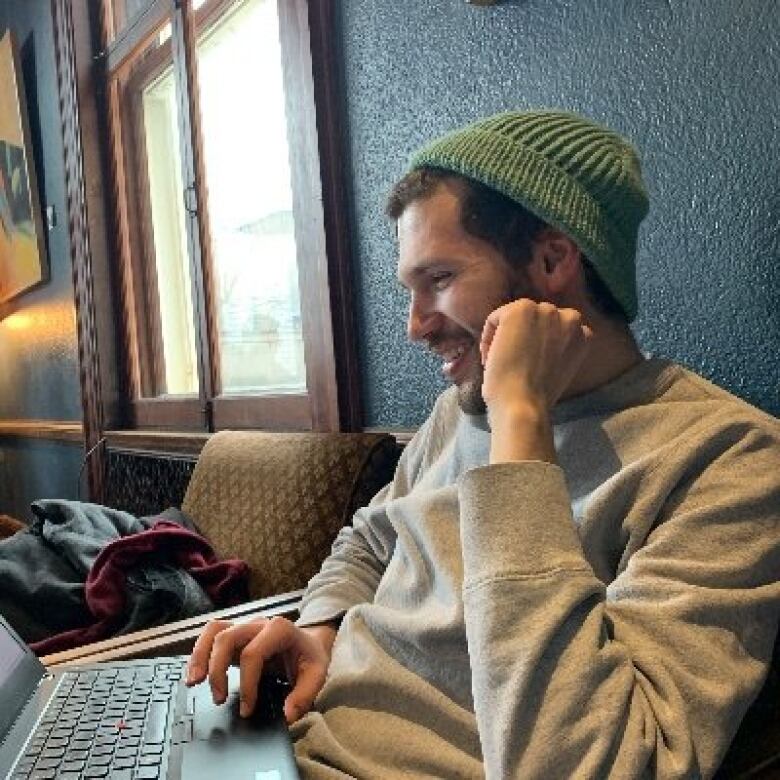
[0,0,83,518]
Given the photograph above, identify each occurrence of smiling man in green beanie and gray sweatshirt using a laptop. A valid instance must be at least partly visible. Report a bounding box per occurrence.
[184,112,780,778]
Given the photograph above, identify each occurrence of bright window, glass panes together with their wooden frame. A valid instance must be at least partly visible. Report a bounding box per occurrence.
[103,0,354,430]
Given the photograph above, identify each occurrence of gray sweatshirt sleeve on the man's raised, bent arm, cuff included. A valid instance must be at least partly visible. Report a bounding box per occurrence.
[459,426,780,780]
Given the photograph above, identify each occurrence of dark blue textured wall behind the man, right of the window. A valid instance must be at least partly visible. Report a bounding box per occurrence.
[335,0,780,426]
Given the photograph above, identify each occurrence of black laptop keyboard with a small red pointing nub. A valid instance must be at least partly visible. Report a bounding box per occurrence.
[11,661,183,780]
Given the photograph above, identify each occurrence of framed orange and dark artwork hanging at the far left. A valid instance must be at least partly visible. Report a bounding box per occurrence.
[0,30,48,304]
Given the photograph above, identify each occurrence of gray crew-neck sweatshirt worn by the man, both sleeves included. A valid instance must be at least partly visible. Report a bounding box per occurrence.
[293,360,780,780]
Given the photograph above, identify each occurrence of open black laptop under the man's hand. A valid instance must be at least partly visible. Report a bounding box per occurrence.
[0,617,299,780]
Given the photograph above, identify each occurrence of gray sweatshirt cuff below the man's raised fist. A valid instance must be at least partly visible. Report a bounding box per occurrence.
[458,461,590,587]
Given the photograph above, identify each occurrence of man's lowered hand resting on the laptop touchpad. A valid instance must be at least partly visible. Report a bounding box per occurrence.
[186,617,336,723]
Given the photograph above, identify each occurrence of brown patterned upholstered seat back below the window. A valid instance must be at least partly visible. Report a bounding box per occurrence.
[182,431,398,598]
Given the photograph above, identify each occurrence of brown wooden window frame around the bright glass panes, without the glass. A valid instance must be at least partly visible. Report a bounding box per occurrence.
[96,0,360,431]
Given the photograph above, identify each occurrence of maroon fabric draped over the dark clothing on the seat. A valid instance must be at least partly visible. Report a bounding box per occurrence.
[31,520,249,655]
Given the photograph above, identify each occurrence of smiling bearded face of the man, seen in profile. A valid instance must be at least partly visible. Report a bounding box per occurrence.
[398,184,533,414]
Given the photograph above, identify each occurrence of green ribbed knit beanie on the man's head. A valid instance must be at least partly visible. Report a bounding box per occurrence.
[410,111,648,321]
